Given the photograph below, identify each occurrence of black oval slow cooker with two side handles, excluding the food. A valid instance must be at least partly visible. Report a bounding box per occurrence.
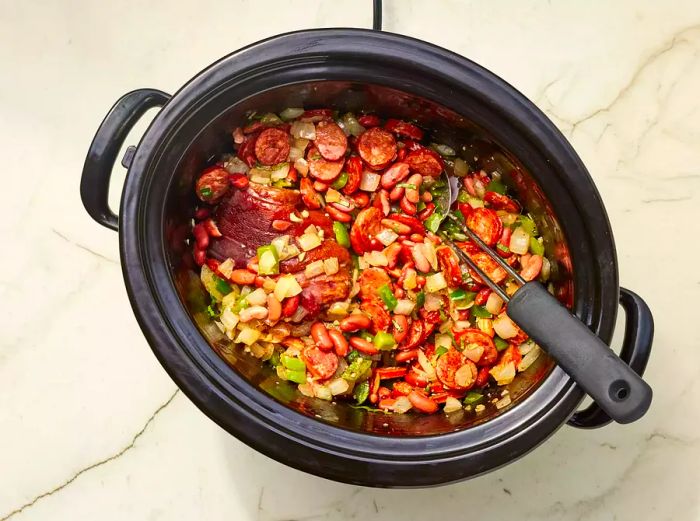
[81,29,653,487]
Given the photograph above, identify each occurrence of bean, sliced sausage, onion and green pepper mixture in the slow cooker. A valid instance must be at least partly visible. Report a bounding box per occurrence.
[192,108,550,414]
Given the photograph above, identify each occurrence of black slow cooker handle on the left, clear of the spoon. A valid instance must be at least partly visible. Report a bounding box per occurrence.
[80,89,170,231]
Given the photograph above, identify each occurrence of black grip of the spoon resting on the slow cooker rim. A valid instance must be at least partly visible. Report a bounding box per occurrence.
[507,282,652,423]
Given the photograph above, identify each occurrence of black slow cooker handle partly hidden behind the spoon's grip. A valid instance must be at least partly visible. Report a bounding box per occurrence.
[569,288,654,429]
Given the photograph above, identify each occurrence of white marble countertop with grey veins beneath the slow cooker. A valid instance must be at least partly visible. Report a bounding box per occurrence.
[0,0,700,521]
